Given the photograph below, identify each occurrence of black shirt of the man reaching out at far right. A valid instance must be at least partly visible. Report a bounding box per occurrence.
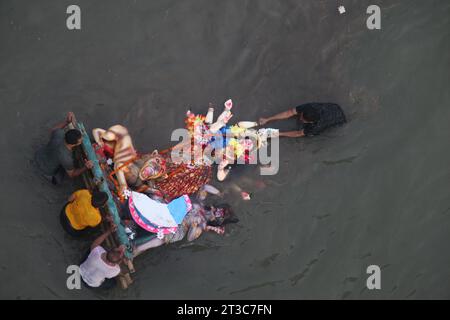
[295,102,347,136]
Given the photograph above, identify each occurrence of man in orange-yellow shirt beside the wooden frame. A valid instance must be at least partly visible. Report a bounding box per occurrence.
[60,189,108,237]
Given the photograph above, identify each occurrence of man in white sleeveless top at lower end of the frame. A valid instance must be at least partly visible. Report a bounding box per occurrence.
[80,226,125,289]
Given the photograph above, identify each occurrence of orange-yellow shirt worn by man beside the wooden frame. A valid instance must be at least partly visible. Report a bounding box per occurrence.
[66,189,102,230]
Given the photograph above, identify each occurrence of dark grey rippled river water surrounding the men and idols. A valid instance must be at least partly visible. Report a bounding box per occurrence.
[0,0,450,299]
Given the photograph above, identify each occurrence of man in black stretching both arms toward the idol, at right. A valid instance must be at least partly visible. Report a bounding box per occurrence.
[259,102,347,138]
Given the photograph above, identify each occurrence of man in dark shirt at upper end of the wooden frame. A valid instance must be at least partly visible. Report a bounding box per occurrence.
[35,112,93,185]
